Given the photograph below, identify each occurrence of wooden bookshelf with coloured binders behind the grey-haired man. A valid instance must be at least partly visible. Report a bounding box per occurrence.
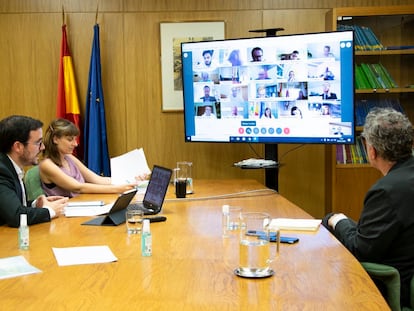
[325,5,414,220]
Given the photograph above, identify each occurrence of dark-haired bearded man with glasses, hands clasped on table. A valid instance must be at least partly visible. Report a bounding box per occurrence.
[0,116,68,227]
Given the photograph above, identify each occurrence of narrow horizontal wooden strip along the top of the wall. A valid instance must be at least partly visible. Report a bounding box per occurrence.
[0,0,412,13]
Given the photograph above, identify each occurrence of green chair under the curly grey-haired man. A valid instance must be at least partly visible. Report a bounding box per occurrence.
[361,262,414,311]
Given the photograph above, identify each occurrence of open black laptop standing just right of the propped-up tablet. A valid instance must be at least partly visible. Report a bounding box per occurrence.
[130,165,172,215]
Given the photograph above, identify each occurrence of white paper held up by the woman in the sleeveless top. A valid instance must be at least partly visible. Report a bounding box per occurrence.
[111,148,151,185]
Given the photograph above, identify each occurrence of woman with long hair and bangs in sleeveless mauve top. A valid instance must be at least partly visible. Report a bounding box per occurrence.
[39,119,137,197]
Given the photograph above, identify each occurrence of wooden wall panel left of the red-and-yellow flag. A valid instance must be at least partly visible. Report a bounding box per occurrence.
[0,14,60,119]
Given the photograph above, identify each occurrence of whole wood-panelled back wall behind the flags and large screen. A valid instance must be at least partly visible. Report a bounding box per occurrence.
[0,0,406,217]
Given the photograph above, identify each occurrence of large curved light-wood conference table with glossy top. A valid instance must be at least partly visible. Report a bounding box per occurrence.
[0,180,389,311]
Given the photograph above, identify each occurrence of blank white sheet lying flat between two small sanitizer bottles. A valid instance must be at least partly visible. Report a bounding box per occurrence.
[52,245,118,266]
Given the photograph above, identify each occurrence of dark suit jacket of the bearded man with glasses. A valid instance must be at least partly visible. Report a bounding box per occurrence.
[0,153,50,227]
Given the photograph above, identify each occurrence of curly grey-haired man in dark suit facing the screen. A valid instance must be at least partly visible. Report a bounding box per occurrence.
[322,108,414,306]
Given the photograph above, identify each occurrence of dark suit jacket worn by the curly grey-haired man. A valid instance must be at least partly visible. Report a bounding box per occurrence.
[326,157,414,305]
